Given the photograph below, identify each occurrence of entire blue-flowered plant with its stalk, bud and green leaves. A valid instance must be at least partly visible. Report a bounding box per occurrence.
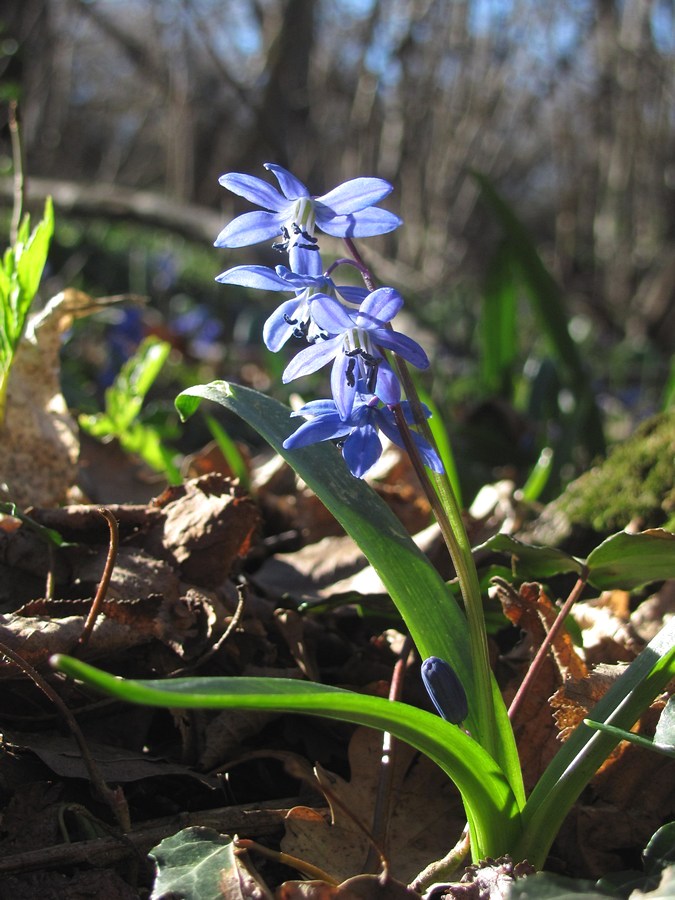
[55,164,675,884]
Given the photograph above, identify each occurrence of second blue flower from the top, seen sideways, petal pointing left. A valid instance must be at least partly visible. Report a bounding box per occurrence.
[216,266,368,353]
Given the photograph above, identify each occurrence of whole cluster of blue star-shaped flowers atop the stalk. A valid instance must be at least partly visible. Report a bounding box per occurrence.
[215,163,442,477]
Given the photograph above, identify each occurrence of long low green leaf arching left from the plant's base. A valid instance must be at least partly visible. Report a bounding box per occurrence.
[52,656,520,858]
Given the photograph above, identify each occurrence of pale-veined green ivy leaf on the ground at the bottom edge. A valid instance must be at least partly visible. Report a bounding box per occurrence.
[149,827,243,900]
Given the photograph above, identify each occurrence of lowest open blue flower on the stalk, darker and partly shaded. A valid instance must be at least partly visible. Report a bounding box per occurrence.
[284,392,443,478]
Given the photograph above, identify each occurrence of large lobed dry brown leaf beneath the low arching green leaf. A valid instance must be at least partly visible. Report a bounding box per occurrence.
[282,728,464,882]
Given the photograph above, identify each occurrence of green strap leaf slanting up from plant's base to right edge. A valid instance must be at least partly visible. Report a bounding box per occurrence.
[513,619,675,867]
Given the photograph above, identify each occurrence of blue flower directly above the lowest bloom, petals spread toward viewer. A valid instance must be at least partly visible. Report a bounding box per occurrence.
[282,287,429,419]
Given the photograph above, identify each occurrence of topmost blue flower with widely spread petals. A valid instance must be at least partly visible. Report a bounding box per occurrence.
[215,163,402,275]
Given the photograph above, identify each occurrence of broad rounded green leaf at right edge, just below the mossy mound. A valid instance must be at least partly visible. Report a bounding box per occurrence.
[586,528,675,591]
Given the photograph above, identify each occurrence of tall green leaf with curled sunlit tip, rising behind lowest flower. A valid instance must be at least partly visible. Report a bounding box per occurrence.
[176,381,525,804]
